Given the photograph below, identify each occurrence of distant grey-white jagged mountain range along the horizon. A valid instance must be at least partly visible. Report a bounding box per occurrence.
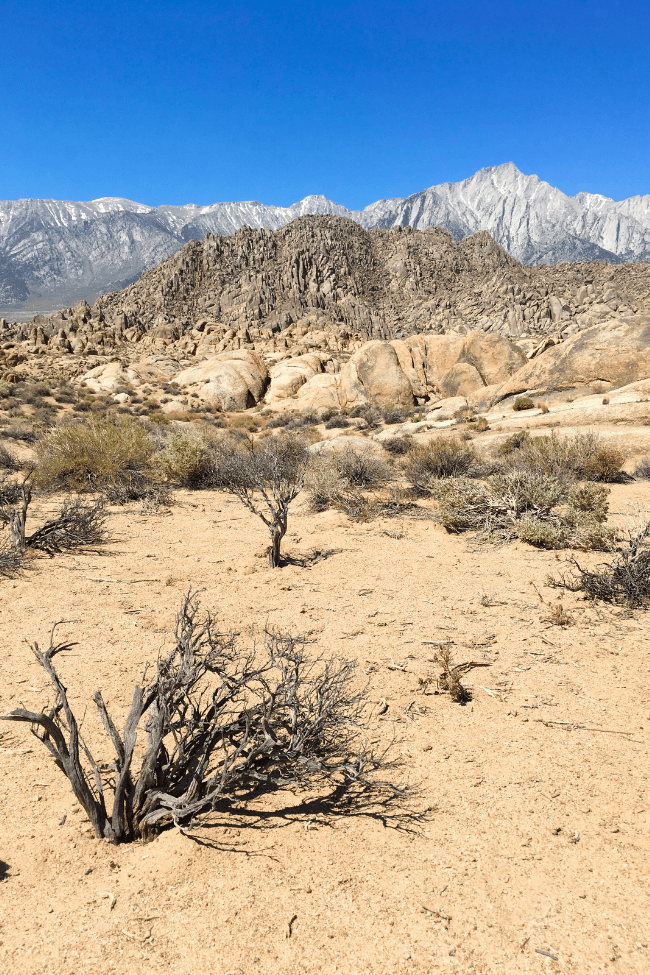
[0,163,650,309]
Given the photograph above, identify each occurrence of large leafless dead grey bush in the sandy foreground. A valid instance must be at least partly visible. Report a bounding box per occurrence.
[3,594,404,842]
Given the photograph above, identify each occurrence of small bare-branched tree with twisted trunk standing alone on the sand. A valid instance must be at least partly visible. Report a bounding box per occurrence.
[211,433,309,568]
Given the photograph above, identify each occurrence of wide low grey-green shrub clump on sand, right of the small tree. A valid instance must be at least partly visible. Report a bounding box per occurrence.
[433,470,616,550]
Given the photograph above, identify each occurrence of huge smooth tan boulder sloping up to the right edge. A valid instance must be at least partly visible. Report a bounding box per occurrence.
[498,316,650,399]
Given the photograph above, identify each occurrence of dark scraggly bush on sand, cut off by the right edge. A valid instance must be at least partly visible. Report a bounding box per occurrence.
[548,522,650,607]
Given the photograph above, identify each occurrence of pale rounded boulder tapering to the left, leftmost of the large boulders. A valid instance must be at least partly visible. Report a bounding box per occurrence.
[174,349,268,410]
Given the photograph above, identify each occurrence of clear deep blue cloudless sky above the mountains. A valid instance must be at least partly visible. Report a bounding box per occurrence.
[0,0,650,208]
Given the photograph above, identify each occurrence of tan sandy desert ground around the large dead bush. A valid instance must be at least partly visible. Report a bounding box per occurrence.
[0,483,650,975]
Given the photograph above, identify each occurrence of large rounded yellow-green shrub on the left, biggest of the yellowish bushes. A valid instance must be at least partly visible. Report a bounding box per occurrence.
[35,415,154,491]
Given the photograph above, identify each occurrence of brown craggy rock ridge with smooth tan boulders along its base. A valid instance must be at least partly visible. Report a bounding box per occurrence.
[0,216,650,420]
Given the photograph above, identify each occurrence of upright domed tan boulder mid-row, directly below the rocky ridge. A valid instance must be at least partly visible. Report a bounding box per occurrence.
[341,341,413,407]
